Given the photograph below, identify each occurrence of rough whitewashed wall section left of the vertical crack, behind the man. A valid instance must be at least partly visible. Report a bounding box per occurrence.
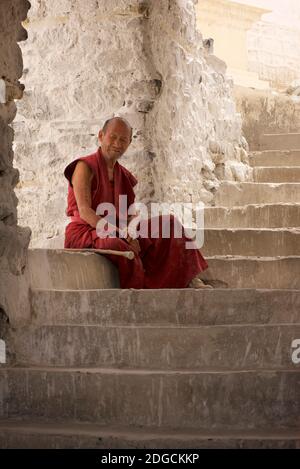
[15,0,155,246]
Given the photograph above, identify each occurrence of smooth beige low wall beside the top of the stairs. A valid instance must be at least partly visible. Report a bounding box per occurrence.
[234,87,300,150]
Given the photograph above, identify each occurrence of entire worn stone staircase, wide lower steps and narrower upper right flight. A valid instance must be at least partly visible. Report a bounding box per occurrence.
[0,134,300,448]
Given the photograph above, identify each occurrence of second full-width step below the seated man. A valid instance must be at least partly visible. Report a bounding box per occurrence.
[13,322,300,371]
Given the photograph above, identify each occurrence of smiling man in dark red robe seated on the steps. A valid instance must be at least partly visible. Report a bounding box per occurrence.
[64,117,212,288]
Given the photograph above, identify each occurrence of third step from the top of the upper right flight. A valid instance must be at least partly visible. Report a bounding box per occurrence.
[253,166,300,182]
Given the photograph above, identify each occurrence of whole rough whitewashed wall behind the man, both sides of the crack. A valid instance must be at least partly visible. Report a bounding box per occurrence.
[15,0,251,246]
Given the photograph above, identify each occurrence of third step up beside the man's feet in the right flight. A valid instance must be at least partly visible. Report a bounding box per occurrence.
[204,204,300,229]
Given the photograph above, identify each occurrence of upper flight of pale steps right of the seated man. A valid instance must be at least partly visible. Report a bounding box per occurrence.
[203,133,300,289]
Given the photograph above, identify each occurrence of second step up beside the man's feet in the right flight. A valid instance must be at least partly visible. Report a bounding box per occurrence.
[201,228,300,257]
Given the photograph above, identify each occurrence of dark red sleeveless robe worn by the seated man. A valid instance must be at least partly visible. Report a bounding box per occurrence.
[64,148,208,288]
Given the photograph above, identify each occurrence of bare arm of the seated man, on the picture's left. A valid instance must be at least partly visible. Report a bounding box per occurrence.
[72,161,101,228]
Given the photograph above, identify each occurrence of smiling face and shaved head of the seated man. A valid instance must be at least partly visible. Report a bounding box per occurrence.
[99,120,131,160]
